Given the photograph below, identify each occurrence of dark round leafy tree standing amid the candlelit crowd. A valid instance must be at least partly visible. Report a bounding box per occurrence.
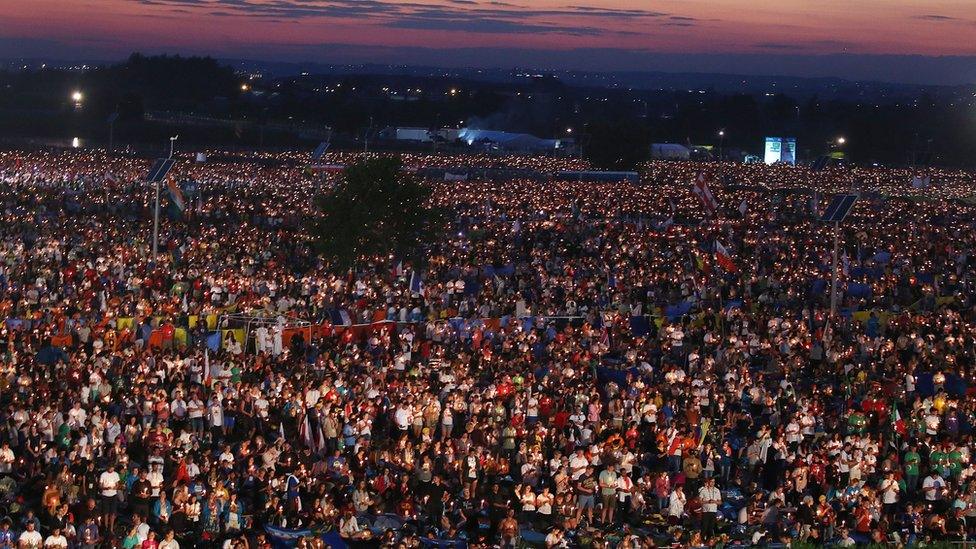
[312,158,441,268]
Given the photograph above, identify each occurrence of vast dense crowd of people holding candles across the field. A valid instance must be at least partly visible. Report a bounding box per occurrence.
[0,148,976,549]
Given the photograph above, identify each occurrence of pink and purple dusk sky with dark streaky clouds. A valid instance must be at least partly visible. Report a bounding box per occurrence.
[0,0,976,84]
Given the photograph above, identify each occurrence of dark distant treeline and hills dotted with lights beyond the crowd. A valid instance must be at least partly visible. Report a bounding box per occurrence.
[0,54,976,169]
